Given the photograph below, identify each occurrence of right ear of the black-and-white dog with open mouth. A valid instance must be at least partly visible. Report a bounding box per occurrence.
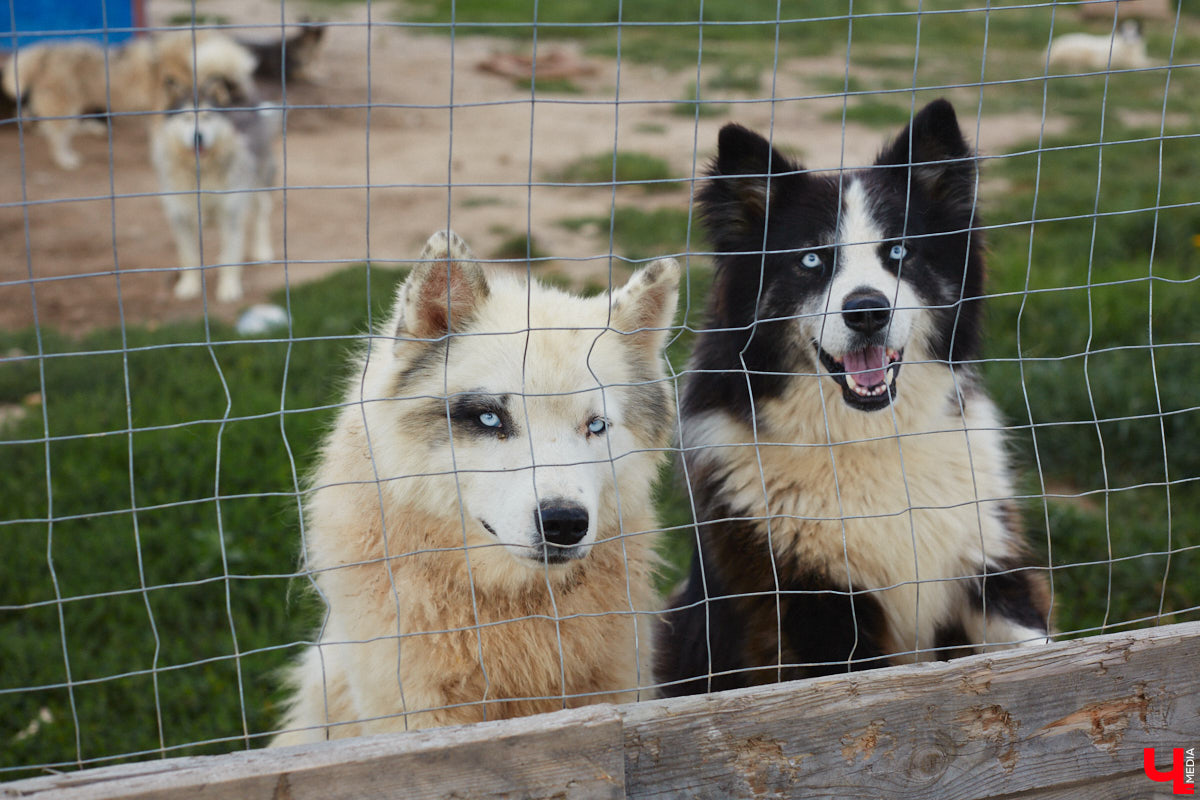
[875,98,976,200]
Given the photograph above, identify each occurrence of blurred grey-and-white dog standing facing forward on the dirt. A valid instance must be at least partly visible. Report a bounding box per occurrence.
[151,36,280,302]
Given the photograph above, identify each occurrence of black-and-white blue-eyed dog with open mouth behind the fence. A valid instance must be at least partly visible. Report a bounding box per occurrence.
[658,100,1050,694]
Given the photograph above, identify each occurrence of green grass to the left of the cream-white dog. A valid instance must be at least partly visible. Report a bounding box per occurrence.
[0,267,408,777]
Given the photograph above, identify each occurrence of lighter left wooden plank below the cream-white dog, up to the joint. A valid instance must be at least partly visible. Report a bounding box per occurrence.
[7,705,624,800]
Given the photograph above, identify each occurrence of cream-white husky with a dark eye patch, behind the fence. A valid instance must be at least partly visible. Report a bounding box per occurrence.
[274,226,679,745]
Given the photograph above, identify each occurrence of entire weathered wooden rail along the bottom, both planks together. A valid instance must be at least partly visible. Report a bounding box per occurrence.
[0,622,1200,800]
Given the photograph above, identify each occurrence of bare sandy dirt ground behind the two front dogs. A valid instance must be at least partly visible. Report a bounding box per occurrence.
[0,0,1065,333]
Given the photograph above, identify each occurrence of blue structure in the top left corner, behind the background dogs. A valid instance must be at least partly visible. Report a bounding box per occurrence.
[0,0,145,50]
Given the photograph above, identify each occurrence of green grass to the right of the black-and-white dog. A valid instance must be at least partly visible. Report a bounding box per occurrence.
[986,112,1200,630]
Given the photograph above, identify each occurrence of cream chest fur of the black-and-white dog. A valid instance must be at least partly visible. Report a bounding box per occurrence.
[685,367,1019,660]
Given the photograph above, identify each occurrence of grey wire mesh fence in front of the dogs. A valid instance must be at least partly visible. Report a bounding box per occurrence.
[0,0,1200,780]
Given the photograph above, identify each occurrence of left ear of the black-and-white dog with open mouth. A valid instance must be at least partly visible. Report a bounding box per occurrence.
[697,124,802,251]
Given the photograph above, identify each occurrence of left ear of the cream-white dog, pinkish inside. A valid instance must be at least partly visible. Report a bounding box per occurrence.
[395,230,490,339]
